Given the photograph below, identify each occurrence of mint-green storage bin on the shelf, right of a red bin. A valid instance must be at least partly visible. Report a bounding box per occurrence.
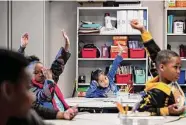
[134,70,146,84]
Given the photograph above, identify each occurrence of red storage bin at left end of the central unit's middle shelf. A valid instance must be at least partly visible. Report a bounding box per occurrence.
[82,48,97,58]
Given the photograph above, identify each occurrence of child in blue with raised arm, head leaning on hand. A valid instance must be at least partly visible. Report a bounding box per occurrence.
[86,45,124,98]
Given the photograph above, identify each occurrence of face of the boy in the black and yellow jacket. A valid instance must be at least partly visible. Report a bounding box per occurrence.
[160,57,181,82]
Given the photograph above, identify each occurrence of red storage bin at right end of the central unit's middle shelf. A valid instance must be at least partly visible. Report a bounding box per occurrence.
[130,49,145,58]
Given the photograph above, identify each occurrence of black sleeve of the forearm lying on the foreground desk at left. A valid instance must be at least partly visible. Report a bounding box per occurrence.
[32,102,58,119]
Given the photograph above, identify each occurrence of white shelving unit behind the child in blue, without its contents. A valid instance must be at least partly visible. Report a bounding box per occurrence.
[76,7,148,94]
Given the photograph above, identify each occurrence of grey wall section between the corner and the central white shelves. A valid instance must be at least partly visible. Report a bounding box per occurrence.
[45,1,77,97]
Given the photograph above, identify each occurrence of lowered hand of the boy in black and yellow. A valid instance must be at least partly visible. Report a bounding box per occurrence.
[168,104,185,115]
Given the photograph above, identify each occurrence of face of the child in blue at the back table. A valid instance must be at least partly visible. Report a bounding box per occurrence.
[98,73,109,88]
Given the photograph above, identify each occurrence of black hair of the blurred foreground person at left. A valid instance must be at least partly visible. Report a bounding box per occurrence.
[0,48,29,84]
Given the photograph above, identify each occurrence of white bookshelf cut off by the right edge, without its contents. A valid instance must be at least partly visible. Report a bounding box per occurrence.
[164,3,186,87]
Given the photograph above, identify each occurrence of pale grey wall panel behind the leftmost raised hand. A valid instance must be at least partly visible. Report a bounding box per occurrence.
[12,1,45,62]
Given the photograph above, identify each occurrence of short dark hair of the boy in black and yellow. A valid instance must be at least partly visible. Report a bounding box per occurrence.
[155,50,179,67]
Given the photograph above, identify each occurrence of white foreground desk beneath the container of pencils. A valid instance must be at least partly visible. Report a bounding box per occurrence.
[45,113,186,125]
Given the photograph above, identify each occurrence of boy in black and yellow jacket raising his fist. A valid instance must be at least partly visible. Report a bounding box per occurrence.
[131,20,185,115]
